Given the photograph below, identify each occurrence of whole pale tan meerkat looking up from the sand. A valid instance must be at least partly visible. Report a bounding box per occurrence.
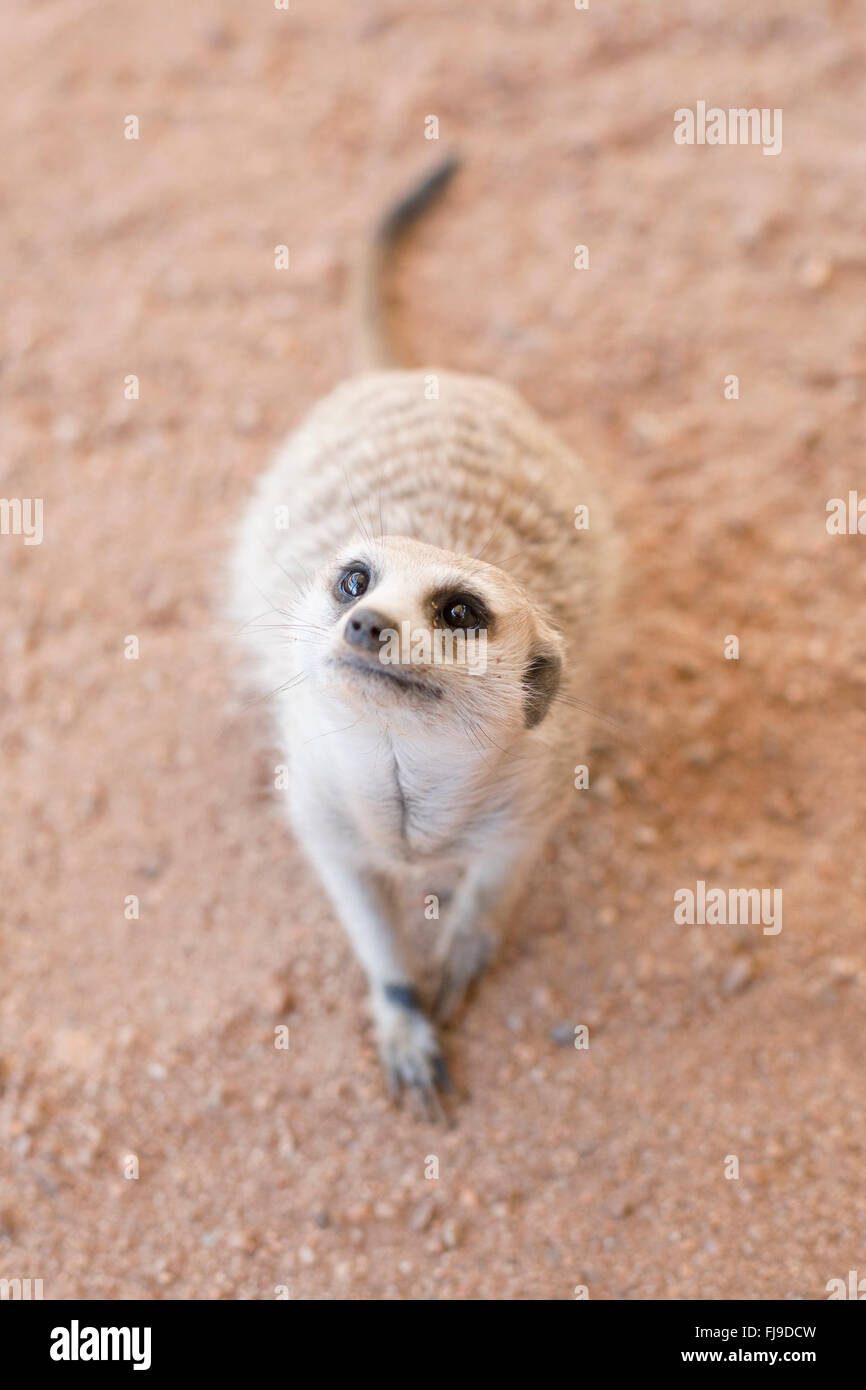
[232,158,613,1106]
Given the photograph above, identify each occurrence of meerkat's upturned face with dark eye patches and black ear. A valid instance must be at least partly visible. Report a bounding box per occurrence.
[297,537,563,734]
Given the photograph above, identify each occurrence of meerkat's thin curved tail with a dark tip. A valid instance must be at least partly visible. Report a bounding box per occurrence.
[354,154,460,370]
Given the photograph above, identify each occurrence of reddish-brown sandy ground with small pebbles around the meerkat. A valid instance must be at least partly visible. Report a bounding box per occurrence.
[0,0,866,1298]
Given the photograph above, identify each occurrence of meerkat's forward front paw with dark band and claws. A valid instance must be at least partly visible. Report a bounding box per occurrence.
[373,986,452,1119]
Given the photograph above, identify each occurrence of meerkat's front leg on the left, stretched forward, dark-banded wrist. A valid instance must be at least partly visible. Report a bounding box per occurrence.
[295,808,450,1111]
